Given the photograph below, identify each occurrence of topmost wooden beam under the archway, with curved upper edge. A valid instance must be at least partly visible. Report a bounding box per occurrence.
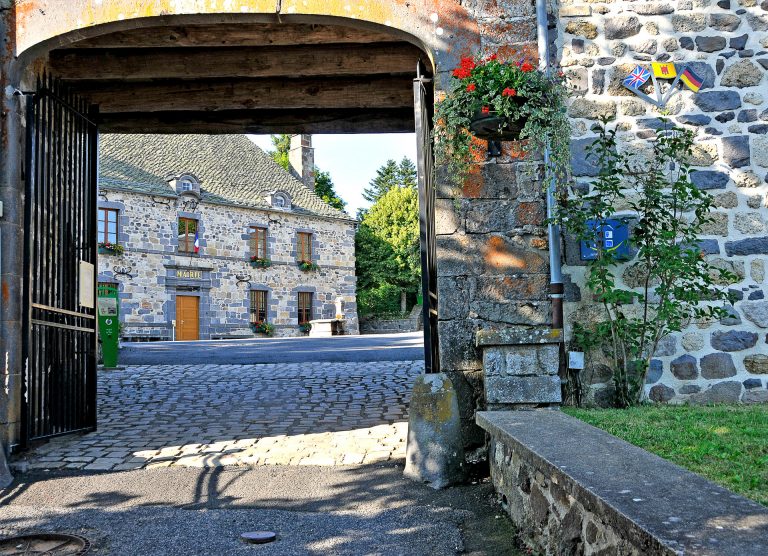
[71,23,396,48]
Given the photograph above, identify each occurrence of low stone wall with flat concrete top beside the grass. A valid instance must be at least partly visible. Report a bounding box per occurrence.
[477,410,768,556]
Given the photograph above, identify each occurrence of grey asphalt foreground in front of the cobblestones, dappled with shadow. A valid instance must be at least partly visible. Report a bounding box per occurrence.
[0,461,519,556]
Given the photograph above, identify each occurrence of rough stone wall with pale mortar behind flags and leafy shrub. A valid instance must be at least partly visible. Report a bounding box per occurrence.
[557,0,768,402]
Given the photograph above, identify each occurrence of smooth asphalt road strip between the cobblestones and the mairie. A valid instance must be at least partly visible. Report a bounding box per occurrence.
[120,332,424,365]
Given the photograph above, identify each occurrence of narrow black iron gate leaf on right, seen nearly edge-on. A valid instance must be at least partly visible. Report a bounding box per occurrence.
[413,69,440,373]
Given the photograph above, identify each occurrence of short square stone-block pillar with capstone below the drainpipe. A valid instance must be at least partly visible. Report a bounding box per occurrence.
[477,329,563,410]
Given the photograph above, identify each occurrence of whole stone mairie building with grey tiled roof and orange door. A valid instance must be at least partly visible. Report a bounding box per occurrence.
[99,134,358,340]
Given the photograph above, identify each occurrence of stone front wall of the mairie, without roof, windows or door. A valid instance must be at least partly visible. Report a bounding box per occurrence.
[99,190,359,339]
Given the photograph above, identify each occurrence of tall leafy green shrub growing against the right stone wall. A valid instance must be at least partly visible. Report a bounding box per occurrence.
[554,120,736,407]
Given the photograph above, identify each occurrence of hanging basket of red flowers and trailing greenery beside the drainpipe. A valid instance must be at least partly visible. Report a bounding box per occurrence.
[433,55,571,186]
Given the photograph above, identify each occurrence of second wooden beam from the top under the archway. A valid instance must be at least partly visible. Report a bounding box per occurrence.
[50,43,422,81]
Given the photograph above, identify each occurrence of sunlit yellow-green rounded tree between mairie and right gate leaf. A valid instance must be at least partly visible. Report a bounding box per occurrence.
[355,186,421,314]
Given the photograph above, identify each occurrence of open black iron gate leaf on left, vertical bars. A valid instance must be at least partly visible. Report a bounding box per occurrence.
[21,77,98,446]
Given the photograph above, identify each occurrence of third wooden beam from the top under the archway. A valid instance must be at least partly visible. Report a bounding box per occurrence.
[75,76,413,113]
